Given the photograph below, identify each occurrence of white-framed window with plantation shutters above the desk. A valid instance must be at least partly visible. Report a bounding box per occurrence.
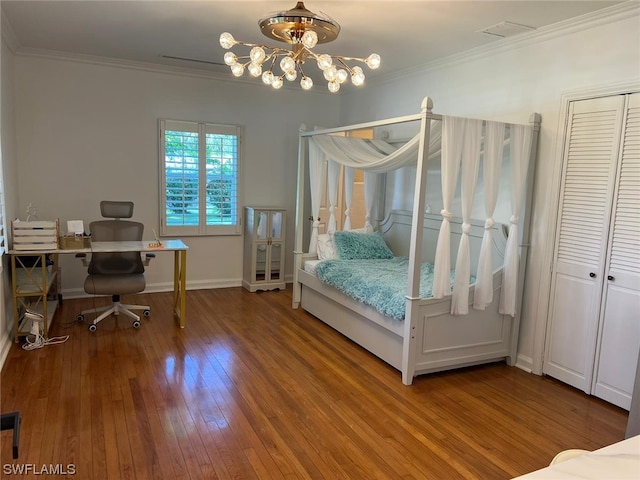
[160,120,241,236]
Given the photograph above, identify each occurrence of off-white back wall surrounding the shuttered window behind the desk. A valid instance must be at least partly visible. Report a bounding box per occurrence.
[10,56,339,297]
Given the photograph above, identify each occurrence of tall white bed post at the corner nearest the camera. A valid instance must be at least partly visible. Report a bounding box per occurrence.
[402,97,433,385]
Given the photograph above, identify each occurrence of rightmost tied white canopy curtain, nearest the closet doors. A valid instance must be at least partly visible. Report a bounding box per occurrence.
[499,125,533,316]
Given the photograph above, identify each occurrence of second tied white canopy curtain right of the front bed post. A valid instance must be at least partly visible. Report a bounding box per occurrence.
[451,119,483,315]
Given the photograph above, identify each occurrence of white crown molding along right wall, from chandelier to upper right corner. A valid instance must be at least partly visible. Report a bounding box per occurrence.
[371,0,640,85]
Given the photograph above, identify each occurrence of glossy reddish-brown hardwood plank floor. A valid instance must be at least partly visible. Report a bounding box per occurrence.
[0,288,627,480]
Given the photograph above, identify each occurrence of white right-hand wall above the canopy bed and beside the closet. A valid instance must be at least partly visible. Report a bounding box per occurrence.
[341,2,640,373]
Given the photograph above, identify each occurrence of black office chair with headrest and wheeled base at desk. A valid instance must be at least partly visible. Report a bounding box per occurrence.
[76,201,154,332]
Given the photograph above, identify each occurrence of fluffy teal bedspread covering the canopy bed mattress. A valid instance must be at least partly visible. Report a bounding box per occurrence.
[316,257,453,320]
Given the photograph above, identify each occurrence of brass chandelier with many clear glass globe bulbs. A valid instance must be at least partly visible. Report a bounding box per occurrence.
[220,2,380,93]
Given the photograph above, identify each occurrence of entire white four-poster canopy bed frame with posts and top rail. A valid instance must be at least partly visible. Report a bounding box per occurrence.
[293,98,539,385]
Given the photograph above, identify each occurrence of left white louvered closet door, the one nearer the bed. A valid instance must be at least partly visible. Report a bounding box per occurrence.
[543,96,625,393]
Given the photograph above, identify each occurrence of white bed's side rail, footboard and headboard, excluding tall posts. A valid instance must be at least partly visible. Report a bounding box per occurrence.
[298,211,517,384]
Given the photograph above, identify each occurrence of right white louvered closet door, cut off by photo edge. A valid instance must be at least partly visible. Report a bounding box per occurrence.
[593,93,640,409]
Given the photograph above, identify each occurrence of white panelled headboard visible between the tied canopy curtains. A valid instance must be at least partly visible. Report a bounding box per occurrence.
[379,210,507,275]
